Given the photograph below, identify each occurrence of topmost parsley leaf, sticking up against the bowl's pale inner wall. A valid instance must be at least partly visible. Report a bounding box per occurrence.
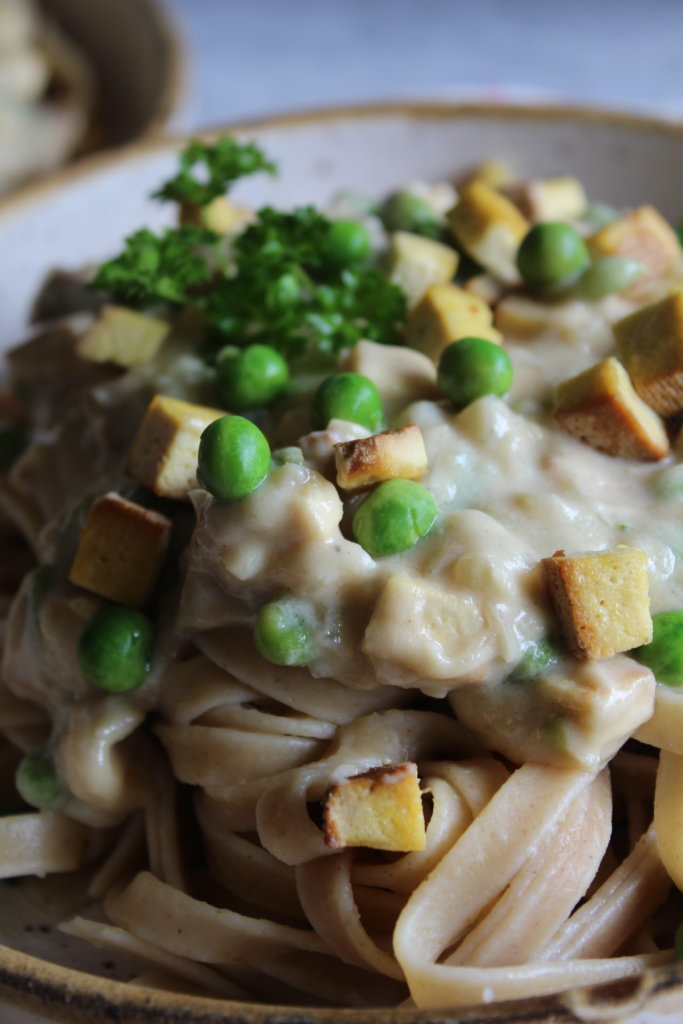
[153,135,275,206]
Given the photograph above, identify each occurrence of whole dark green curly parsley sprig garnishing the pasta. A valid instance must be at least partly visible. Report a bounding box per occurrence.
[93,138,405,360]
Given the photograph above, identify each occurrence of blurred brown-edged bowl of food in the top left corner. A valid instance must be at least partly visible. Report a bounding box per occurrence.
[0,0,182,193]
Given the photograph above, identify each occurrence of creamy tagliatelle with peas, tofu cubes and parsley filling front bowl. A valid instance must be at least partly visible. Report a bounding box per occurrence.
[0,138,683,1009]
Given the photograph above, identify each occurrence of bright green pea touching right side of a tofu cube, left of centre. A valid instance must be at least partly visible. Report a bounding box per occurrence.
[197,416,270,502]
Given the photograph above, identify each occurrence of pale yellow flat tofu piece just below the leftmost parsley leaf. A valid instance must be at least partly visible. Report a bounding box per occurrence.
[76,306,170,368]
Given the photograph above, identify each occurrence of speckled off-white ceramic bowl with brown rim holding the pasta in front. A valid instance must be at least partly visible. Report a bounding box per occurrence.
[0,104,683,1024]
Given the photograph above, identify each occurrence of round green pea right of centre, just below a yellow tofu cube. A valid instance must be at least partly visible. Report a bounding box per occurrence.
[436,338,513,409]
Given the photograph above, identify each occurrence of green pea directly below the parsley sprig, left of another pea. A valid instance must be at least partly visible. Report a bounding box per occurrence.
[216,344,290,412]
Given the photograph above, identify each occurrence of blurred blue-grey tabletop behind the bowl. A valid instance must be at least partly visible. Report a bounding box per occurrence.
[165,0,683,130]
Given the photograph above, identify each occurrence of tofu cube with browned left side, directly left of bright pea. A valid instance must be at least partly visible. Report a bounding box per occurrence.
[126,394,225,499]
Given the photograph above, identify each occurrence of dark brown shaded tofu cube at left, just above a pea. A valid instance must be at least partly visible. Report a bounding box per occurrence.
[69,493,171,607]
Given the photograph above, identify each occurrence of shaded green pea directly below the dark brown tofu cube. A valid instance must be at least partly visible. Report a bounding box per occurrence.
[77,604,154,693]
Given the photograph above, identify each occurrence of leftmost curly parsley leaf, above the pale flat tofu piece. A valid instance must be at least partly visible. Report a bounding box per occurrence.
[92,224,217,305]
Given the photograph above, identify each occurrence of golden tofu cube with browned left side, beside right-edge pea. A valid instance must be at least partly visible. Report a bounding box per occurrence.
[542,545,652,660]
